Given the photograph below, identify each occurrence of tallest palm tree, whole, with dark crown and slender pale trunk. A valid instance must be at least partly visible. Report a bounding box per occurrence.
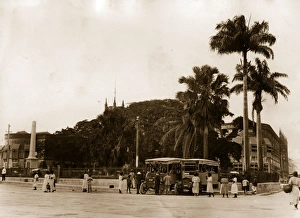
[210,15,276,171]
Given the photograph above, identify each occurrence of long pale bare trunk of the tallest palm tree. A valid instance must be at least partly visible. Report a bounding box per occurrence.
[243,52,250,171]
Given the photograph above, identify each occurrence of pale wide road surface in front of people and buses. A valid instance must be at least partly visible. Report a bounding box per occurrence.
[0,182,300,218]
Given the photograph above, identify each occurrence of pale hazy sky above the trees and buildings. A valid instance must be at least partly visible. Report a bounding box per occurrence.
[0,0,300,166]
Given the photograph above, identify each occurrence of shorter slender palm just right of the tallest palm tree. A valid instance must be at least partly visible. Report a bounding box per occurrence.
[231,58,290,171]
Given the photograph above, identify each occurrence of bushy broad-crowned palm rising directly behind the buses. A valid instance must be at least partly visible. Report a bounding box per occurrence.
[177,65,231,158]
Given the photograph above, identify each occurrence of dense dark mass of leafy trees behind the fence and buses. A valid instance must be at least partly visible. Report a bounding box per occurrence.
[44,99,241,171]
